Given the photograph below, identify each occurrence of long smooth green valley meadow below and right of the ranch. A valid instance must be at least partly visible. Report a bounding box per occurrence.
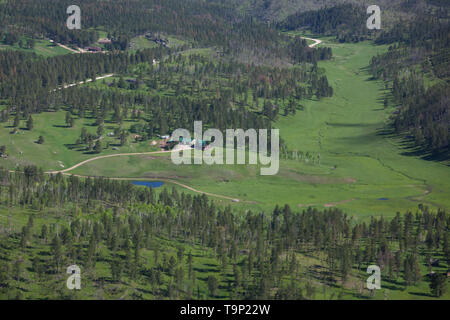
[55,38,450,218]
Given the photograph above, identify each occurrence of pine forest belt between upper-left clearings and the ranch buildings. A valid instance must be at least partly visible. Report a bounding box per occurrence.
[0,34,333,156]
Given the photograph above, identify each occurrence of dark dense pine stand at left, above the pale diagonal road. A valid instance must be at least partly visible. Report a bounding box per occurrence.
[0,48,170,114]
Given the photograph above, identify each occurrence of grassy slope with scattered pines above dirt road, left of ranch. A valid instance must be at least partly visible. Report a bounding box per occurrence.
[0,111,158,170]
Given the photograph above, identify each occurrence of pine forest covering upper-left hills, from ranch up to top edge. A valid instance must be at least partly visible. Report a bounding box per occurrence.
[0,0,333,154]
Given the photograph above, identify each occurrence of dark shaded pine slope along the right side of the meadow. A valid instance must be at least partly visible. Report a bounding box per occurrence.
[371,15,450,159]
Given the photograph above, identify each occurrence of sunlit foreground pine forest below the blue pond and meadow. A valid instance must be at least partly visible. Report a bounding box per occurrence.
[0,167,450,299]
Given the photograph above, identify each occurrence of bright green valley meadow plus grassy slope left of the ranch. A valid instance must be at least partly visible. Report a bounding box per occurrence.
[0,38,450,219]
